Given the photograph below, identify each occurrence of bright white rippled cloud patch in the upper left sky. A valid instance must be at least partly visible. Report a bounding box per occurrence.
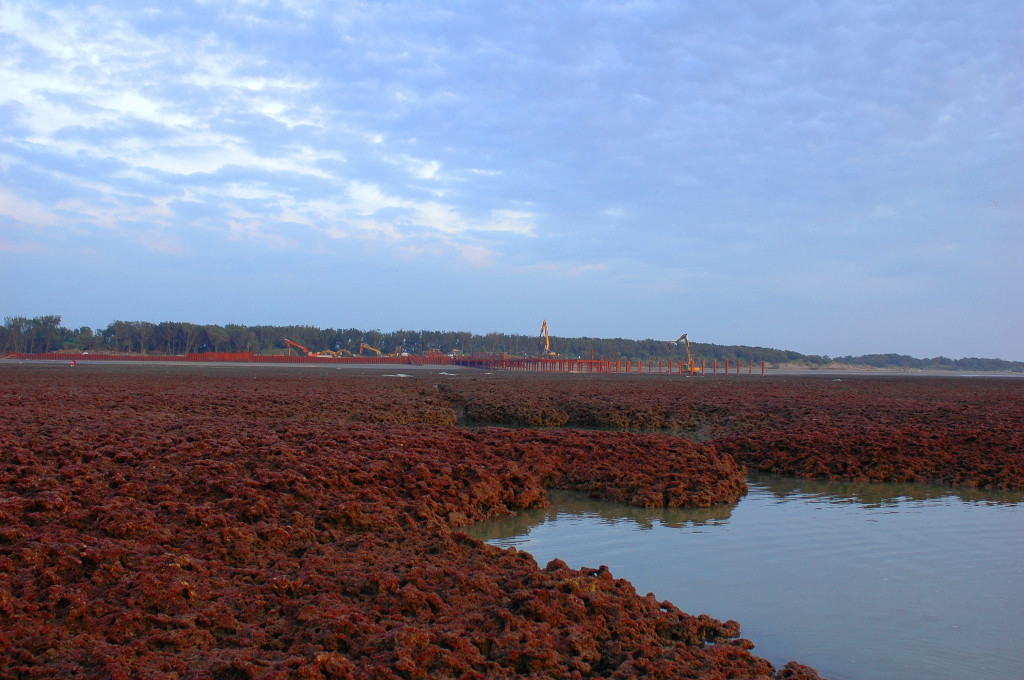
[0,4,532,264]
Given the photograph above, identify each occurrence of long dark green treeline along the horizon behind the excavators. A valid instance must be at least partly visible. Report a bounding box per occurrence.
[0,314,1024,372]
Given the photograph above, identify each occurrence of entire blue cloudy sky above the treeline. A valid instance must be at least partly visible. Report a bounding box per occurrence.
[0,0,1024,360]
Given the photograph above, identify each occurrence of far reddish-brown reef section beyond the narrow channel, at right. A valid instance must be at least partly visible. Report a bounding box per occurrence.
[441,375,1024,490]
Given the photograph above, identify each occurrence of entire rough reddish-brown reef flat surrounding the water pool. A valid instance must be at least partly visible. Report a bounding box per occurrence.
[0,366,1024,679]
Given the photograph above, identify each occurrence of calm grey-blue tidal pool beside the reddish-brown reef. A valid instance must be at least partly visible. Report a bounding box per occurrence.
[468,475,1024,680]
